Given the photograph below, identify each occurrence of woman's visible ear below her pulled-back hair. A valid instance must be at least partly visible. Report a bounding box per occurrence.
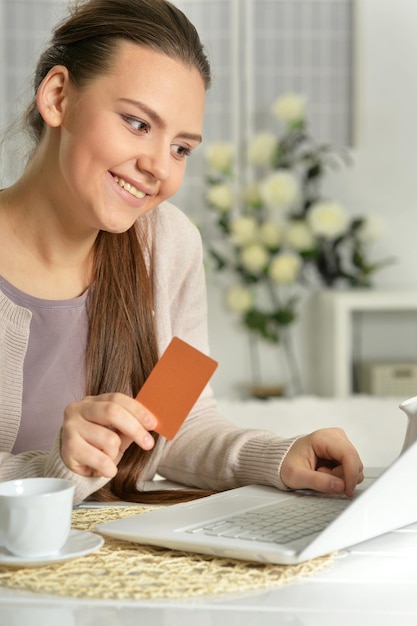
[36,65,70,128]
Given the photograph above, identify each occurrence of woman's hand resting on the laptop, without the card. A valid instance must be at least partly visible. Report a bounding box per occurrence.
[281,428,364,498]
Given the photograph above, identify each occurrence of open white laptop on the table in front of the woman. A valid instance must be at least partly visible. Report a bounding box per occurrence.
[97,442,417,564]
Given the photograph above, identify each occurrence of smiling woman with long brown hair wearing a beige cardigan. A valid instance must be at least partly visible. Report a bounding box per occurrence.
[0,0,363,502]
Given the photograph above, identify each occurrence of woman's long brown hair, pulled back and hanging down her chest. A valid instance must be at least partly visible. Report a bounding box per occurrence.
[25,0,210,501]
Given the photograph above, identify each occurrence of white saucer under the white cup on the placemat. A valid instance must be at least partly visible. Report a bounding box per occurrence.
[0,530,104,567]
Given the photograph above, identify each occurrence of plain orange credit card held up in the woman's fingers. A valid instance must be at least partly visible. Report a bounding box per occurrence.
[136,337,218,439]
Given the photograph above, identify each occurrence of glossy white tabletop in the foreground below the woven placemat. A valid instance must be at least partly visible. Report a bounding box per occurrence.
[0,526,417,626]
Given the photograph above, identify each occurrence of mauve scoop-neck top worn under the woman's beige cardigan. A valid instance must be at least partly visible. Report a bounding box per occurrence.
[0,277,88,454]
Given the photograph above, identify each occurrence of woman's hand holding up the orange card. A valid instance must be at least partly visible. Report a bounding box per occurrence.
[61,393,157,478]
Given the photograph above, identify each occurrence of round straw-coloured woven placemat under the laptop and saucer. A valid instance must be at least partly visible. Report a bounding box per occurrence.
[0,505,335,600]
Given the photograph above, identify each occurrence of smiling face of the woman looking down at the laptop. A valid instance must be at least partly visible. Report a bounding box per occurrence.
[39,42,205,232]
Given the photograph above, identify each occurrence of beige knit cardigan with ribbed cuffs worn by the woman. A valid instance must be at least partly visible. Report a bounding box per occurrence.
[0,202,295,502]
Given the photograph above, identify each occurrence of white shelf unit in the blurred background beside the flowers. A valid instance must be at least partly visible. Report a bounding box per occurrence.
[311,290,417,397]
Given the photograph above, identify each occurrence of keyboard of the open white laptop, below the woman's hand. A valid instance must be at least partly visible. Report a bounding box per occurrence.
[187,496,351,543]
